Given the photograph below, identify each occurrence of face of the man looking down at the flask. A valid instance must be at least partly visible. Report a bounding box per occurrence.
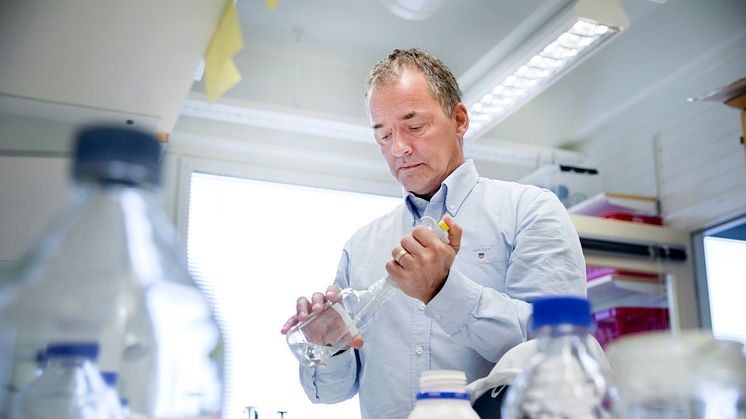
[368,69,469,198]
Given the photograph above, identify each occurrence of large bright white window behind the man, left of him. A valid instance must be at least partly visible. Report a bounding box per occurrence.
[187,172,401,419]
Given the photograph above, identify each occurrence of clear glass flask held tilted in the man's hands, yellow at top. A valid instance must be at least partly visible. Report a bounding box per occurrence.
[285,216,448,367]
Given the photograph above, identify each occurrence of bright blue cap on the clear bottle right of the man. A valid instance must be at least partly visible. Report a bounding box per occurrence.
[532,296,591,330]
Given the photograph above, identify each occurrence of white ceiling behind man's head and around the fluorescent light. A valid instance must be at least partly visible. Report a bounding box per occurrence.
[183,0,746,179]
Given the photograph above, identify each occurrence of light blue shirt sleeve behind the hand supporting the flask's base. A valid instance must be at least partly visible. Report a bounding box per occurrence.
[299,248,360,403]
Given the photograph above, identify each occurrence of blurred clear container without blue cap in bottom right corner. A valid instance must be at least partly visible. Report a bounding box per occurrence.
[608,330,746,419]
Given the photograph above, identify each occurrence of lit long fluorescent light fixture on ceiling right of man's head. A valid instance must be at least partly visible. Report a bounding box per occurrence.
[465,0,629,140]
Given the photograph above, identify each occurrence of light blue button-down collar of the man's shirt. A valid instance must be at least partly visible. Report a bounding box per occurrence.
[404,159,479,220]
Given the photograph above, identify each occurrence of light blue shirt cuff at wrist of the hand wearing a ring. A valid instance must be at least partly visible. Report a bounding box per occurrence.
[425,269,484,336]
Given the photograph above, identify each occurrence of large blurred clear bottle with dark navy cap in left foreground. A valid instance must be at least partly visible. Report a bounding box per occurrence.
[0,127,222,418]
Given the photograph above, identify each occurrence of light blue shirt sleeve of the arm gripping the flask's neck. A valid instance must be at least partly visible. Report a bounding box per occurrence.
[425,191,586,362]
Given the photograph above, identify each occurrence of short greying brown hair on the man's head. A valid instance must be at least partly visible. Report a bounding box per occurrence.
[365,48,461,118]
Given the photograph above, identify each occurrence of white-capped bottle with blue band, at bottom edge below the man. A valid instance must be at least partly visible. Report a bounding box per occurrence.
[407,370,479,419]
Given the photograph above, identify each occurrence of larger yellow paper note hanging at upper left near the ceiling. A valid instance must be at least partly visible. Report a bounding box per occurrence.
[205,0,243,102]
